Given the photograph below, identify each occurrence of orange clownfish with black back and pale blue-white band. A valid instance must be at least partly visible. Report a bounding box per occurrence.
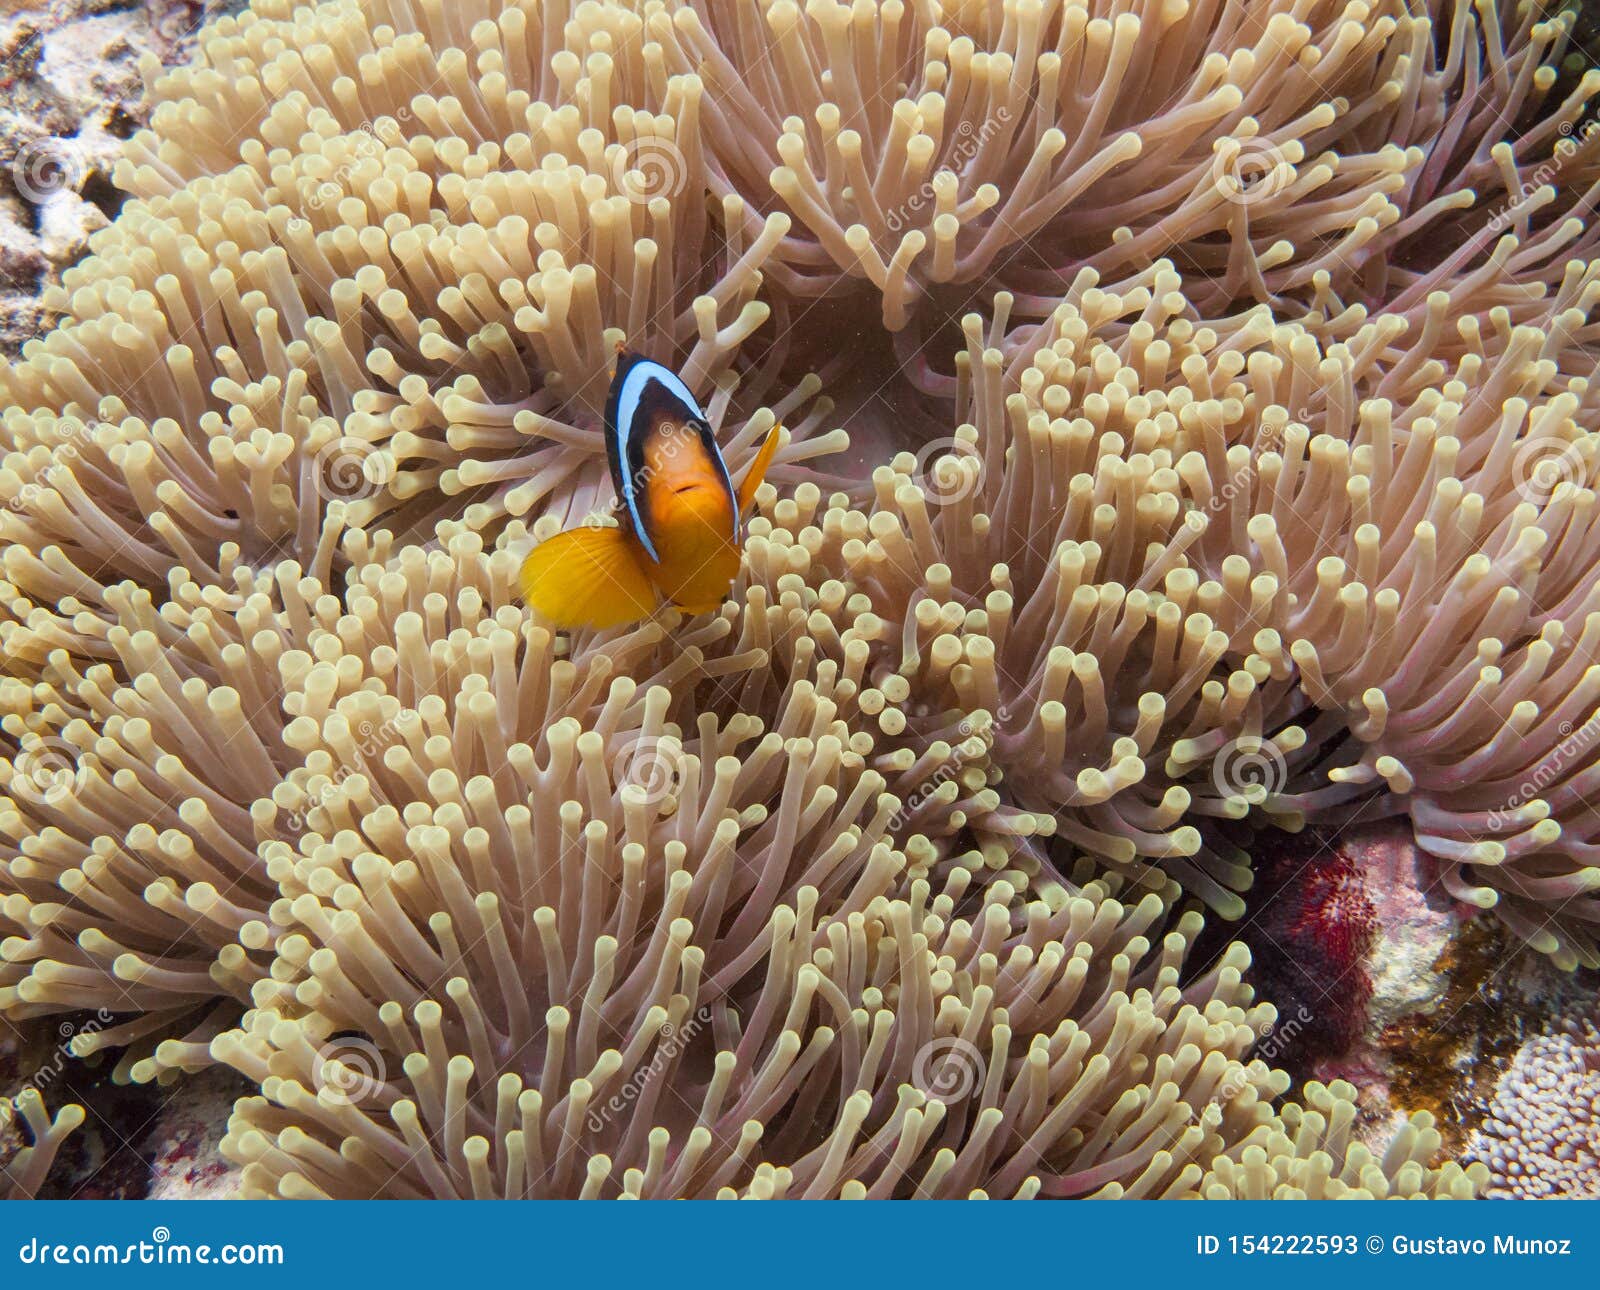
[522,354,779,627]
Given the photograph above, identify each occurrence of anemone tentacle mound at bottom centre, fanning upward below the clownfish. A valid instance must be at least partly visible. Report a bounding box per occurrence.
[200,576,1324,1197]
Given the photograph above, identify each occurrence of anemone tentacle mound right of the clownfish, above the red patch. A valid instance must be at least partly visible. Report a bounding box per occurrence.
[750,264,1600,965]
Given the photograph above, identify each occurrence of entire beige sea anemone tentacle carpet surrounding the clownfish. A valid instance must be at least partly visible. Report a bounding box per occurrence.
[0,0,1600,1197]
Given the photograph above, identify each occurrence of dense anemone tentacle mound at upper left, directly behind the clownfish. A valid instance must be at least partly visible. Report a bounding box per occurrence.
[81,3,840,550]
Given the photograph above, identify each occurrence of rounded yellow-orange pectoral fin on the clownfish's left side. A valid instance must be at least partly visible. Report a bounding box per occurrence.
[522,527,659,627]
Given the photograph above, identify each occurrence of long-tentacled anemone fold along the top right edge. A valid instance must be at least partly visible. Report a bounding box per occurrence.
[645,0,1600,330]
